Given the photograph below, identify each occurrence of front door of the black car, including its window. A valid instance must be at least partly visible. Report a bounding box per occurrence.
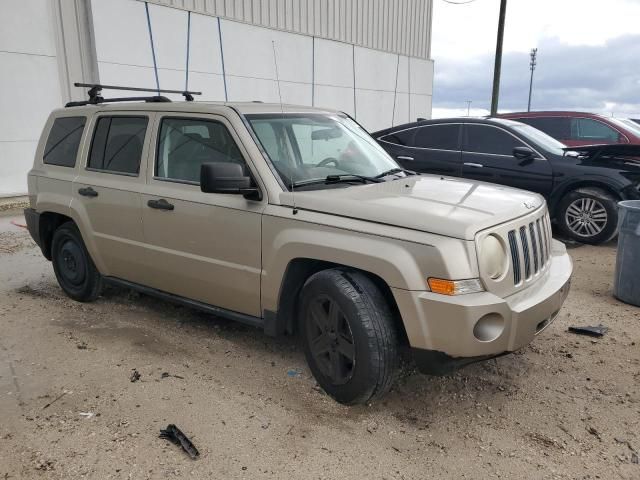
[462,123,553,196]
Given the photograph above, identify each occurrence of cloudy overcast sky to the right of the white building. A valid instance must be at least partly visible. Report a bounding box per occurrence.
[431,0,640,118]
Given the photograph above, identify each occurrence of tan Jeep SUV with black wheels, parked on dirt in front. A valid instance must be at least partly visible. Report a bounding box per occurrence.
[25,92,572,404]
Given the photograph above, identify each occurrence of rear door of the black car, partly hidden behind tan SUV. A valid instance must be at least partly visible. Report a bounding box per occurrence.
[380,123,462,176]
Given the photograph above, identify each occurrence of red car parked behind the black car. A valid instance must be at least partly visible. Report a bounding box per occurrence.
[498,111,640,147]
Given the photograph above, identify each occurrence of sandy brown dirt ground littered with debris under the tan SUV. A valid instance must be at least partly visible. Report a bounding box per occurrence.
[0,214,640,479]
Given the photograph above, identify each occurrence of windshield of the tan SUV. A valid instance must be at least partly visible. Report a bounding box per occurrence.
[247,113,399,189]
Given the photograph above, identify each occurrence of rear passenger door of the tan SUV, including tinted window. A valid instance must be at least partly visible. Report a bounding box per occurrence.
[71,112,152,283]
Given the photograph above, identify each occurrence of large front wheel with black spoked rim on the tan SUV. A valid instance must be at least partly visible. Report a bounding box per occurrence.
[299,269,401,405]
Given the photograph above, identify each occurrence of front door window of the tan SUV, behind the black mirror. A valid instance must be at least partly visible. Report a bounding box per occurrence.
[155,118,246,183]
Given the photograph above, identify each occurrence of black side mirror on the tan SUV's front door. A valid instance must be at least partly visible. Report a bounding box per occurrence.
[200,162,260,199]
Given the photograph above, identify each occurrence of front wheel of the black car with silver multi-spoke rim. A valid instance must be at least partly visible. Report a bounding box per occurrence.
[556,187,618,245]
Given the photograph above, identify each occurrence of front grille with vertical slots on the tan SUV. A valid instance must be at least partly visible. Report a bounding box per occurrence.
[507,214,551,285]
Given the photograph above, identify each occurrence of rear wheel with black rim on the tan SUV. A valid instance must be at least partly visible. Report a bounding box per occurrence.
[51,222,102,302]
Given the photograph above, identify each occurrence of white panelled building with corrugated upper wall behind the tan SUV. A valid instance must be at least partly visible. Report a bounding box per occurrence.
[0,0,433,197]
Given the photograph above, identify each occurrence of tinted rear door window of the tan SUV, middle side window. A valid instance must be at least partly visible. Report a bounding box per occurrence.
[87,117,149,174]
